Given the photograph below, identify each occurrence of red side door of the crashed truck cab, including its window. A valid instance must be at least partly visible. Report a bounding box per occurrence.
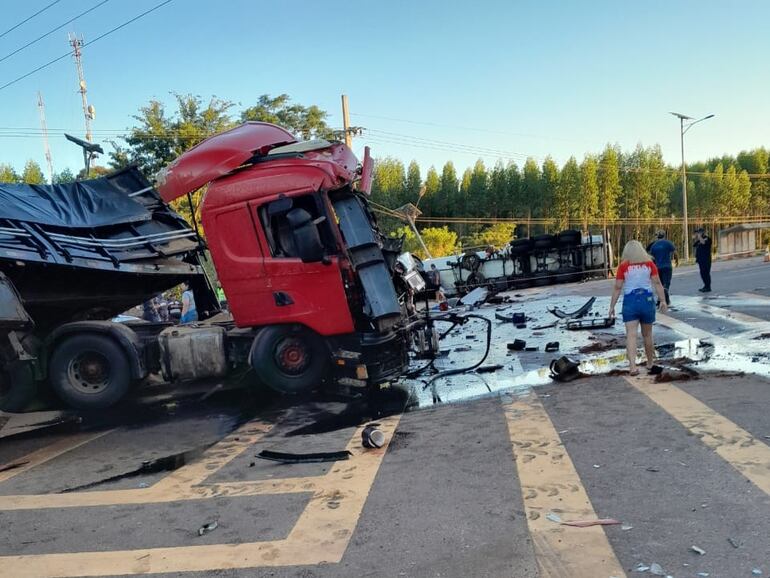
[246,194,353,336]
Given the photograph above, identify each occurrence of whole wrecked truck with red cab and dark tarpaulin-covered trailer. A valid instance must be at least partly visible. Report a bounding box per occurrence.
[0,122,424,411]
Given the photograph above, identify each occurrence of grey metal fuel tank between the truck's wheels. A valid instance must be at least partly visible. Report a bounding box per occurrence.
[158,325,227,381]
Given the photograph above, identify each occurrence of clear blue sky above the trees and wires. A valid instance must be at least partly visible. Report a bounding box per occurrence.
[0,0,770,180]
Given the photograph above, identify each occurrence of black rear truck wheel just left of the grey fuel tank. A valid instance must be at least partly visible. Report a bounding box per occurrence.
[48,334,131,409]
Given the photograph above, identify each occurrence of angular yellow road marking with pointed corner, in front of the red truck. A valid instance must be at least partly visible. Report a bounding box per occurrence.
[0,416,400,578]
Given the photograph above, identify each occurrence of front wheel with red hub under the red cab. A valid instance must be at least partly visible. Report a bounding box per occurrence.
[250,325,329,394]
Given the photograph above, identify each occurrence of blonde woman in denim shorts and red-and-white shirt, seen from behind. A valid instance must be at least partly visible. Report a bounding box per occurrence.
[610,241,668,375]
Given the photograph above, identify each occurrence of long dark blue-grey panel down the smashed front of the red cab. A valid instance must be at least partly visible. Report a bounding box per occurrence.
[332,195,401,328]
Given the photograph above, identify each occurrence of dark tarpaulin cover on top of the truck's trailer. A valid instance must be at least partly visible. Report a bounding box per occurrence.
[0,179,152,228]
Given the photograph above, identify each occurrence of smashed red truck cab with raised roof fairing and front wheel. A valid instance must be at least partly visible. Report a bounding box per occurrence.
[158,122,410,392]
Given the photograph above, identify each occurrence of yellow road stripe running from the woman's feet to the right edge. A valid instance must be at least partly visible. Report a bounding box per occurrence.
[627,378,770,494]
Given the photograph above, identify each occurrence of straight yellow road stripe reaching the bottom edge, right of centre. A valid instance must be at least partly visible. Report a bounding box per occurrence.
[504,395,626,578]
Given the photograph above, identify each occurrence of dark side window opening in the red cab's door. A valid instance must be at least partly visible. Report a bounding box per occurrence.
[259,195,334,259]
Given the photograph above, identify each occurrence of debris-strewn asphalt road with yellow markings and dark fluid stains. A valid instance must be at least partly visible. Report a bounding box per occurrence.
[0,259,770,578]
